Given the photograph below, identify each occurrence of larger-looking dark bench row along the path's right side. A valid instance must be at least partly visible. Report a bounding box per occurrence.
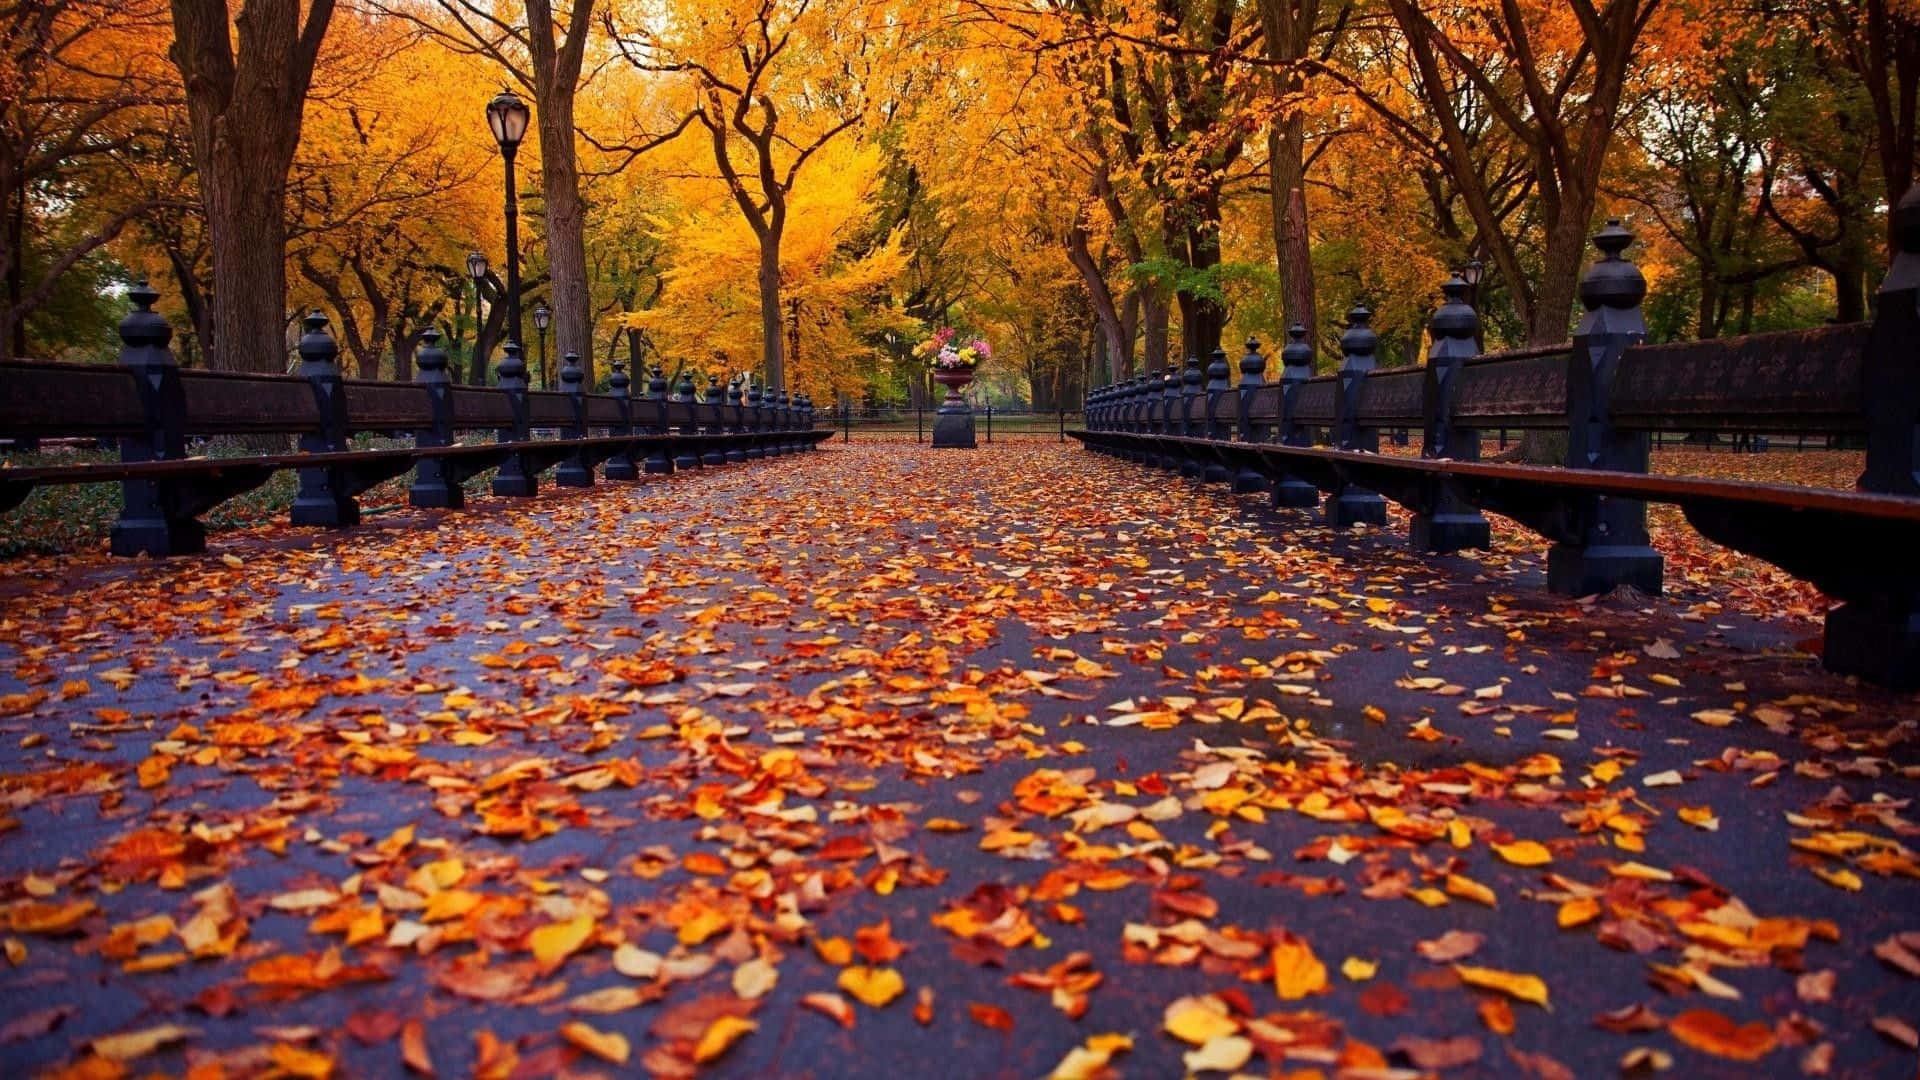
[1071,188,1920,690]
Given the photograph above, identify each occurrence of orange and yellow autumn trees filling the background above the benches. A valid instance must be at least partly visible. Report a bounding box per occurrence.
[0,0,1920,399]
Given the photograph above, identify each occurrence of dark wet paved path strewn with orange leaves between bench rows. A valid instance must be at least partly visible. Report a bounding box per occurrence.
[0,444,1920,1078]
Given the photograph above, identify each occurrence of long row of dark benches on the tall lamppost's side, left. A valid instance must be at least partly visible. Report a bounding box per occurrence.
[0,284,833,555]
